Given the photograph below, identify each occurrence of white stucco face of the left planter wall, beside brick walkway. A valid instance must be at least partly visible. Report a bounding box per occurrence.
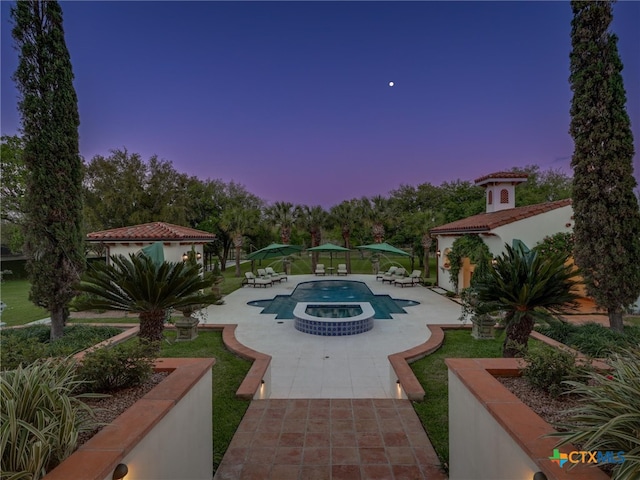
[114,373,213,480]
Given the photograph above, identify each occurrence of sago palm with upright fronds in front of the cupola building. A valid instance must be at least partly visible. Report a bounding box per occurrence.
[474,245,579,357]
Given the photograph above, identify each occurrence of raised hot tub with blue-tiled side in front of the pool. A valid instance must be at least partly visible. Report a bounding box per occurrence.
[293,302,375,337]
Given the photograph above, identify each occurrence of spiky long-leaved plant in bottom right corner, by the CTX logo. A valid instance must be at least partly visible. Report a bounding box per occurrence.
[552,347,640,480]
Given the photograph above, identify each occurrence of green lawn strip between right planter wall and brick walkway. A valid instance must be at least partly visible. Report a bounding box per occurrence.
[411,330,541,471]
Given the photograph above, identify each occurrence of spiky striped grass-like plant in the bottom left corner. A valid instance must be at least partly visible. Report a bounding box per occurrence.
[0,359,96,480]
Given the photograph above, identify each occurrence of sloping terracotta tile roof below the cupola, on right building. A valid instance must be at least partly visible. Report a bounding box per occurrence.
[431,198,571,235]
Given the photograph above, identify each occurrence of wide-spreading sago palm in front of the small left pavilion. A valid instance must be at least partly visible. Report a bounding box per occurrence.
[73,254,218,342]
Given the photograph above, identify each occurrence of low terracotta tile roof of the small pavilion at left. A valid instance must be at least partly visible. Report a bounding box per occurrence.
[87,222,216,242]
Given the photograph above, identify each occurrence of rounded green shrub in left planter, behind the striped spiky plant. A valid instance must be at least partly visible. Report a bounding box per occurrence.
[78,339,158,392]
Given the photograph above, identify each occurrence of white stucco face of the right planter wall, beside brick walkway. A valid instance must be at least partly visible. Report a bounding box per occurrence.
[449,371,539,480]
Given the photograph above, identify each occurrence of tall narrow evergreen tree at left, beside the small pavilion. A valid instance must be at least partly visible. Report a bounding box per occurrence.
[11,0,84,339]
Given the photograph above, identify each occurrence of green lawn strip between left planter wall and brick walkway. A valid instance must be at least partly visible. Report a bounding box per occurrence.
[159,330,251,471]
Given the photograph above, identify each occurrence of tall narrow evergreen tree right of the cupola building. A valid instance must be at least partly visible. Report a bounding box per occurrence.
[569,1,640,331]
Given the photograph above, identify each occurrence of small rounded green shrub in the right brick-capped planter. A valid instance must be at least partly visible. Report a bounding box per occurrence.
[522,346,586,397]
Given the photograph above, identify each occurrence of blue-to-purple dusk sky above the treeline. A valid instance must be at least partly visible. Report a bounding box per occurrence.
[0,1,640,208]
